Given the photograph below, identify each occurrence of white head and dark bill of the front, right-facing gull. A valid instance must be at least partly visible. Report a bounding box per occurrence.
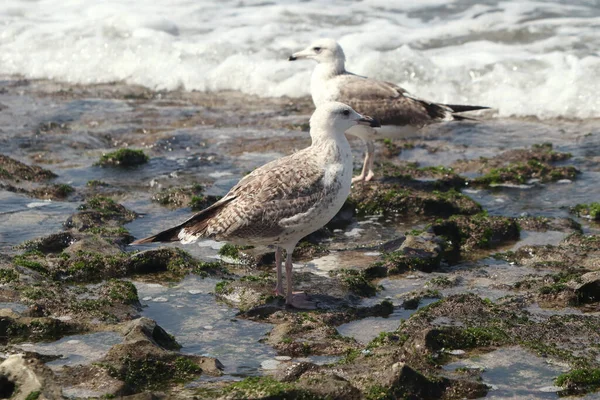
[310,101,381,139]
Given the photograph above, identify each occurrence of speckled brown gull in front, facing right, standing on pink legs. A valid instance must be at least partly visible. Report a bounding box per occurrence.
[131,102,380,308]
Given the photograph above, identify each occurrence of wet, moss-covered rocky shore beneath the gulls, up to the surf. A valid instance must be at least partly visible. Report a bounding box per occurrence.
[0,80,600,400]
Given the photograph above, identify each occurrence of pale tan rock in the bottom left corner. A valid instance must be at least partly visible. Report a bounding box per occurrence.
[0,354,62,400]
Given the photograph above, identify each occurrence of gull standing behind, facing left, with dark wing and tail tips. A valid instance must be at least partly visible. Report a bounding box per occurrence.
[288,39,489,182]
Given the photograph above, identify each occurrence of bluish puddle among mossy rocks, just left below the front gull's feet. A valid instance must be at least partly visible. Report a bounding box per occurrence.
[135,275,277,376]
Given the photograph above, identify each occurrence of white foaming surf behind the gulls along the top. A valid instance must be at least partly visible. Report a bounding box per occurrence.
[0,0,600,119]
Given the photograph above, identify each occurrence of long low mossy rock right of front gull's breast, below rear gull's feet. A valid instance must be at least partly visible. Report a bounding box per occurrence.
[349,182,481,217]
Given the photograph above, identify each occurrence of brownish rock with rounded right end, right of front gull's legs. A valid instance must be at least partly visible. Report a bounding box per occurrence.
[364,232,443,278]
